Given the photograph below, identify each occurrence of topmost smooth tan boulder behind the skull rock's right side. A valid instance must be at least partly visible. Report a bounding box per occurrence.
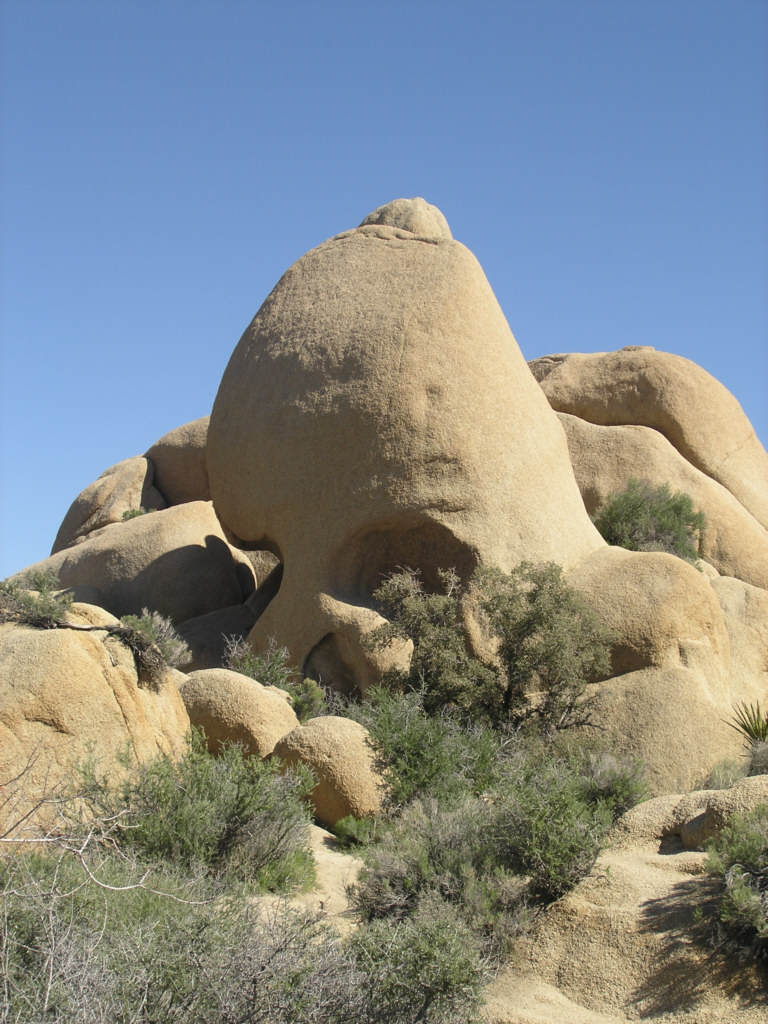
[529,346,768,528]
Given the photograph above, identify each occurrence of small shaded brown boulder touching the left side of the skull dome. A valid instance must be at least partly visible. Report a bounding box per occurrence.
[144,416,211,505]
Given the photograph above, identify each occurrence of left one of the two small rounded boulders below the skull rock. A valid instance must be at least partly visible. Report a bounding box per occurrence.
[180,669,299,758]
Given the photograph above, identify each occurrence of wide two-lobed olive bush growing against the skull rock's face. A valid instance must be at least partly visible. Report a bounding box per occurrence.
[366,562,610,735]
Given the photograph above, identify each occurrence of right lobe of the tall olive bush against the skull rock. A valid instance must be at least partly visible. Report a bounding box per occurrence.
[481,562,610,736]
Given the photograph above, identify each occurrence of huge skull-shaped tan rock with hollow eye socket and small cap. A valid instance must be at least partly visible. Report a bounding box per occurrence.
[207,199,603,690]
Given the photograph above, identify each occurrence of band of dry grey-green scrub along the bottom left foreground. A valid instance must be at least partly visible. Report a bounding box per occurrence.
[0,835,483,1024]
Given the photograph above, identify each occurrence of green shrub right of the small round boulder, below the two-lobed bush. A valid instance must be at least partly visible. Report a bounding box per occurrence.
[344,686,504,807]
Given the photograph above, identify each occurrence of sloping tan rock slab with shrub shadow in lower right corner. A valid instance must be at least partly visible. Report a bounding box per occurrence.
[485,779,766,1024]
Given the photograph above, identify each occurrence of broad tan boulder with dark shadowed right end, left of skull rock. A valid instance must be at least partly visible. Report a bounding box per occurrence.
[21,502,254,623]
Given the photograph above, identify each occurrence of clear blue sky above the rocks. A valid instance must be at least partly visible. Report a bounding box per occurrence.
[0,0,768,577]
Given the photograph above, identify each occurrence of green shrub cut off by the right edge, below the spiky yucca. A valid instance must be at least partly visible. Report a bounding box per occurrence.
[708,804,768,961]
